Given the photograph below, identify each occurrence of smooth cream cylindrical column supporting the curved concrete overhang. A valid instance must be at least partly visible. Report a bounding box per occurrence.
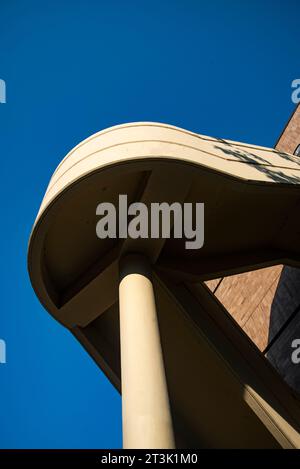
[119,255,175,449]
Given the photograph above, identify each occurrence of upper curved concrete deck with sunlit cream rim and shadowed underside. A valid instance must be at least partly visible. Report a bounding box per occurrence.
[28,123,300,326]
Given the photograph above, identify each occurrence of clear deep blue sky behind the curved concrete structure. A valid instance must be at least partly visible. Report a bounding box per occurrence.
[0,0,300,448]
